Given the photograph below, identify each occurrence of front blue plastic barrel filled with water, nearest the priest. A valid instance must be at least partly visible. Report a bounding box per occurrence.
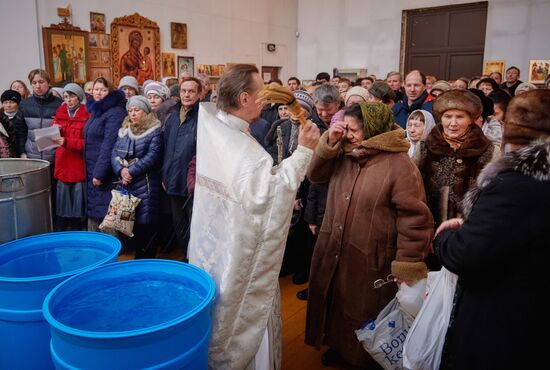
[43,260,215,370]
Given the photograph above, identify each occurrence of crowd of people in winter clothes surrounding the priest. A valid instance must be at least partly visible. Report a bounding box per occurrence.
[0,67,550,369]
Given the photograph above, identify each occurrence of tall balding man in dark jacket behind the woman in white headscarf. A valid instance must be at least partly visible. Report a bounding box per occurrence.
[392,70,435,129]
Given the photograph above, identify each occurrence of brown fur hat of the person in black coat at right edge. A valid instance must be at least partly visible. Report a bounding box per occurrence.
[502,89,550,145]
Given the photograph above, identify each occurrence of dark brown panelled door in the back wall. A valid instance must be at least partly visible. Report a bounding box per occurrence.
[404,2,487,80]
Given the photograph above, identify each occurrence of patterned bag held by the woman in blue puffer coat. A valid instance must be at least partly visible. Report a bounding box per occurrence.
[99,190,141,237]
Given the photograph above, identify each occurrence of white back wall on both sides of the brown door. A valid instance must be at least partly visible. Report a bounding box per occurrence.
[298,0,550,79]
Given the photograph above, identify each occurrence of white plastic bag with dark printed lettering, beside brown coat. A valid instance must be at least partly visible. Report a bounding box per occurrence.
[355,298,414,370]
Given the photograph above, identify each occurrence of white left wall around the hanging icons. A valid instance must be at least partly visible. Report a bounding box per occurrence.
[0,0,298,90]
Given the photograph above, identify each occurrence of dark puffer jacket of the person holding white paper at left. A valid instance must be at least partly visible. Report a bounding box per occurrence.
[19,91,63,163]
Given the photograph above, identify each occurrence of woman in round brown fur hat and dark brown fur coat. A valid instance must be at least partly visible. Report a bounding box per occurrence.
[413,90,500,226]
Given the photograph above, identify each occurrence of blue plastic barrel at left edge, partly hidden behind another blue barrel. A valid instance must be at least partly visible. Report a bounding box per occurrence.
[0,232,120,370]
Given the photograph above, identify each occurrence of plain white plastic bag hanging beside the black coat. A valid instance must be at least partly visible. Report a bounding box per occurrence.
[403,268,458,370]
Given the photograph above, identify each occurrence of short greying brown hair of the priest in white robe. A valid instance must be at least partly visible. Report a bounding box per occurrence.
[216,64,259,112]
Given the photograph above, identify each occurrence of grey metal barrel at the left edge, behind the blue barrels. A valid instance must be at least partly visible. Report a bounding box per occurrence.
[0,158,52,243]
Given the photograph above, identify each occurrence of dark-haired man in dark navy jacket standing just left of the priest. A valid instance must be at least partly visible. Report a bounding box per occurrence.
[162,77,202,259]
